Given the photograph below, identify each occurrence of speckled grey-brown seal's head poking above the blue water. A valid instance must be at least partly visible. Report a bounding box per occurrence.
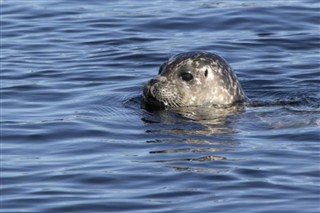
[143,52,247,109]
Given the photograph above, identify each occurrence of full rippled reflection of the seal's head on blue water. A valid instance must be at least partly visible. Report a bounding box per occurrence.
[142,105,244,173]
